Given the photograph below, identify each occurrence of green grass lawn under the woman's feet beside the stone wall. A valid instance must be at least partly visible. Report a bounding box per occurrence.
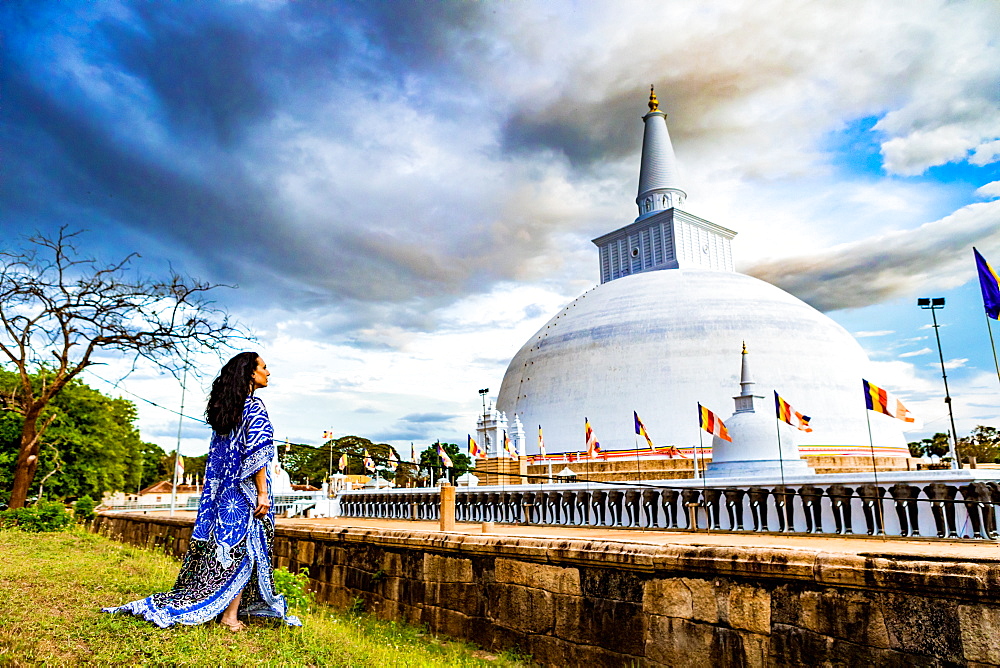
[0,530,526,666]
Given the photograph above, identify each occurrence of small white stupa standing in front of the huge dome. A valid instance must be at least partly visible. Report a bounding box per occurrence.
[706,343,815,478]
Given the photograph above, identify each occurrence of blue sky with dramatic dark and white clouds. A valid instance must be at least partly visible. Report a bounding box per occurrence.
[0,0,1000,454]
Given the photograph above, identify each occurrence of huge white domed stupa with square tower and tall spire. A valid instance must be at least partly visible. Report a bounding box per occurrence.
[497,86,909,456]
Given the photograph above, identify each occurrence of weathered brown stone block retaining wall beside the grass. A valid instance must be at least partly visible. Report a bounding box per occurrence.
[95,514,1000,667]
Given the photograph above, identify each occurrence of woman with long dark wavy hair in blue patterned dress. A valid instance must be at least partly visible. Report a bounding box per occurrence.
[104,353,301,631]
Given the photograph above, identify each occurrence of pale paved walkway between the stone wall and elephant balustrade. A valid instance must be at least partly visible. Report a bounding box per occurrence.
[278,517,1000,561]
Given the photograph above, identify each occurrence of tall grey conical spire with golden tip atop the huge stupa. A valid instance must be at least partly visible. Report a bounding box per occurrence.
[635,86,687,220]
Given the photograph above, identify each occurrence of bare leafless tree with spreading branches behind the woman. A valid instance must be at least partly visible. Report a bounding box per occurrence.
[0,227,240,508]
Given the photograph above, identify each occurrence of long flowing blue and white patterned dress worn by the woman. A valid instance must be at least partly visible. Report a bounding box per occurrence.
[103,395,301,628]
